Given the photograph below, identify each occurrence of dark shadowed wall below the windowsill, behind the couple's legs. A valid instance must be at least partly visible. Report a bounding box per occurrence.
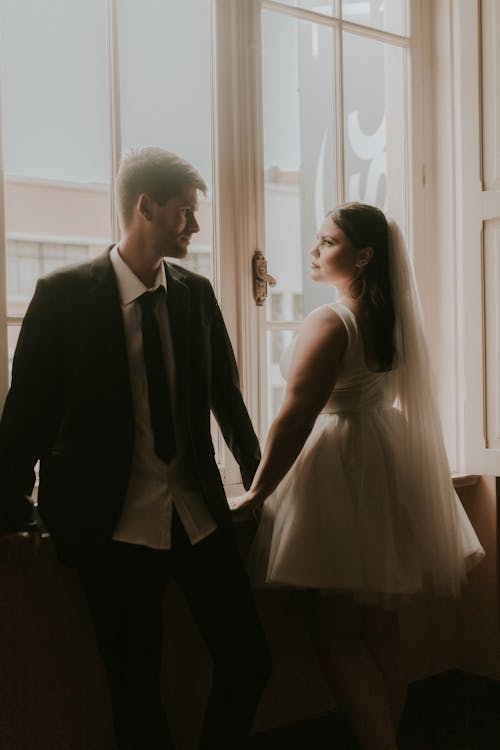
[0,478,500,750]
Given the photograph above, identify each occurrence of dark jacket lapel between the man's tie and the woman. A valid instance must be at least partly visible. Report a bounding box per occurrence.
[165,263,191,406]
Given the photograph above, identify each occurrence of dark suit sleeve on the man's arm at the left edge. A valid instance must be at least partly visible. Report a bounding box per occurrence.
[0,280,62,533]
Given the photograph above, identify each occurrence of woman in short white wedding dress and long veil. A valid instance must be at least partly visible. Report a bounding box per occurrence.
[230,203,484,750]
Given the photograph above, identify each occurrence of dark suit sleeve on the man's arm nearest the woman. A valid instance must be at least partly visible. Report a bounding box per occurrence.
[211,293,260,489]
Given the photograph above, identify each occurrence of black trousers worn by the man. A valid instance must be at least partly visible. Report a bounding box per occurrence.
[78,511,270,750]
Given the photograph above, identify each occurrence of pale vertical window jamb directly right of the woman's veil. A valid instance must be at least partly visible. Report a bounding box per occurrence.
[411,0,465,473]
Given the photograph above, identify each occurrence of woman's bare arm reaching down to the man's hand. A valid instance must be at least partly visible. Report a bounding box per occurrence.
[229,306,347,510]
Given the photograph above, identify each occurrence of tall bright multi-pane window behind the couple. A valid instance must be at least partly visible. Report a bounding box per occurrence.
[7,0,480,481]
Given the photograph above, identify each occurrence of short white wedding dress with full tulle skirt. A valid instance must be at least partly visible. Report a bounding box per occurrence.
[249,303,484,607]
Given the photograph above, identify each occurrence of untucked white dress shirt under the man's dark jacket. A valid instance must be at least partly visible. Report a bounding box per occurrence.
[110,245,217,549]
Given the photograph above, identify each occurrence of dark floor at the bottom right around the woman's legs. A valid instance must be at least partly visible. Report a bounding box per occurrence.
[252,671,500,750]
